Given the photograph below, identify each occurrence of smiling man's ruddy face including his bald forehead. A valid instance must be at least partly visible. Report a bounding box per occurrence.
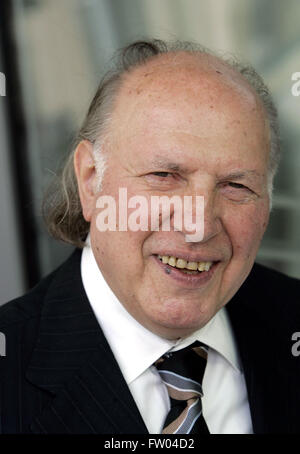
[77,54,269,339]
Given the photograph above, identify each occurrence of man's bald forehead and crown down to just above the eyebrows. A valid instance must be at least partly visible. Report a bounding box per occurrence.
[110,53,269,168]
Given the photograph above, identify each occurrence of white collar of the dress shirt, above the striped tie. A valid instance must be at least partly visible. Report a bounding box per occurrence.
[81,239,241,384]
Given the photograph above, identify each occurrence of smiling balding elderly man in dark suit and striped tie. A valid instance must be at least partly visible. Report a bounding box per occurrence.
[0,41,300,434]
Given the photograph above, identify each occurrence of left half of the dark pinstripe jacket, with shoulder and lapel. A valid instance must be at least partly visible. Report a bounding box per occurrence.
[0,251,147,434]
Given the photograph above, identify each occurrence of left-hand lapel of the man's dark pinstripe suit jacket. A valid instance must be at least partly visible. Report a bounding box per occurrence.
[26,250,147,433]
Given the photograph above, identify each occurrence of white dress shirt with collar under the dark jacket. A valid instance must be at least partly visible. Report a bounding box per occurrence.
[81,239,252,434]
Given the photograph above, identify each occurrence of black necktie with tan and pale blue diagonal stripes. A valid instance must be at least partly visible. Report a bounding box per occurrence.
[155,341,209,434]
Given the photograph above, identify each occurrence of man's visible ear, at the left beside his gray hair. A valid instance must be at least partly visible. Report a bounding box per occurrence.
[74,140,97,222]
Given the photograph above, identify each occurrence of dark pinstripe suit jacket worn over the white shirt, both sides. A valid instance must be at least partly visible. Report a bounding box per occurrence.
[0,250,300,434]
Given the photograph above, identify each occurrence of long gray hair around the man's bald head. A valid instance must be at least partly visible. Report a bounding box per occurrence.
[43,40,280,247]
